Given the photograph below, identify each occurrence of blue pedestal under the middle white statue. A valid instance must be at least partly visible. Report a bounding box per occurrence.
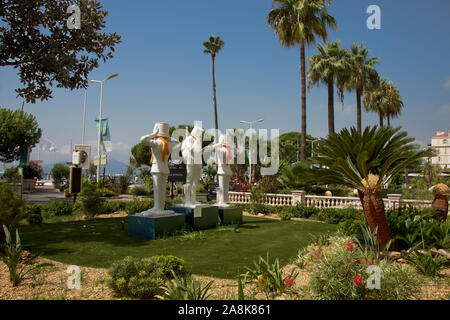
[169,206,219,230]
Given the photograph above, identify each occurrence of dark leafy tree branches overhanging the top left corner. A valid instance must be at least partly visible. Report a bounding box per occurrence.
[0,0,120,103]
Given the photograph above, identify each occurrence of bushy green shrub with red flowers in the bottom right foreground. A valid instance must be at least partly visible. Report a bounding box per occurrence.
[309,237,419,300]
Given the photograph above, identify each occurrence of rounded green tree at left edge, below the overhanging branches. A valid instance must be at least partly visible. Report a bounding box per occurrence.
[0,108,42,163]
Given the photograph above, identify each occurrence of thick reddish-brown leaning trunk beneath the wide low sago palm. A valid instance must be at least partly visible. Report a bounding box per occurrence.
[358,191,399,250]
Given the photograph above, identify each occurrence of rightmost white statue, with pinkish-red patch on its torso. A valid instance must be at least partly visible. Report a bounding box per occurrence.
[212,134,234,207]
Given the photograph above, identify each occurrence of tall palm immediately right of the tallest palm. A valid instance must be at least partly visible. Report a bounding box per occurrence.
[308,40,348,134]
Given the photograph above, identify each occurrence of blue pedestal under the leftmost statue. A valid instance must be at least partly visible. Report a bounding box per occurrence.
[128,213,185,240]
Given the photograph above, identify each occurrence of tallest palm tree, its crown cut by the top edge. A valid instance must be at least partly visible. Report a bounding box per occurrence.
[267,0,336,161]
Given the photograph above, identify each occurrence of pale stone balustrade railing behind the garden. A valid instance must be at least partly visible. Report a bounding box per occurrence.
[228,191,448,210]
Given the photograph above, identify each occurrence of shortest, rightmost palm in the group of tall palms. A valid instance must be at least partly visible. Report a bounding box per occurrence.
[364,78,403,126]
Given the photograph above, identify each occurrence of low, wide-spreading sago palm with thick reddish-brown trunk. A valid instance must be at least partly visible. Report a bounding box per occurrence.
[302,126,430,250]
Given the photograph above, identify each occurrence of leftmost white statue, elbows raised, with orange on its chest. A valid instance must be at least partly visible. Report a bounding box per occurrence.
[141,122,180,216]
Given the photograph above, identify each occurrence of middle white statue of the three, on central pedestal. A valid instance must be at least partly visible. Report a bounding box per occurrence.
[181,127,204,208]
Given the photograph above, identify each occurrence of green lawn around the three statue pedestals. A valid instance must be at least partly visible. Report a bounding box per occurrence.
[19,217,336,278]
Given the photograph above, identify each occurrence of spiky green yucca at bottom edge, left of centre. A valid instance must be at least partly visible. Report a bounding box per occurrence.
[156,271,214,300]
